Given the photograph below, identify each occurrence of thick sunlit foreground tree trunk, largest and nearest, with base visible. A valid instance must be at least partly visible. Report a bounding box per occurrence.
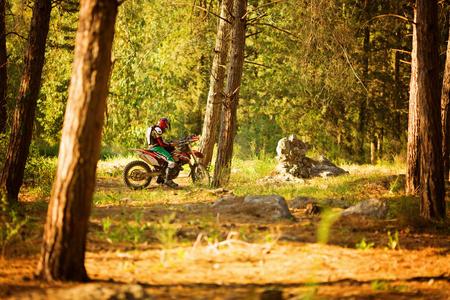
[38,0,118,281]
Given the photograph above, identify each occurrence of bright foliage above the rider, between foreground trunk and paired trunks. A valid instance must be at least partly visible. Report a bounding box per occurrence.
[104,1,215,148]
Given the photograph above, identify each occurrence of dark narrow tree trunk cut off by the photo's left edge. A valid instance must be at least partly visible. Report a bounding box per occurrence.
[0,0,8,134]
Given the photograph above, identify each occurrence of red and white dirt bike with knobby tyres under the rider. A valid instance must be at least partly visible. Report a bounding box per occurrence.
[122,135,211,190]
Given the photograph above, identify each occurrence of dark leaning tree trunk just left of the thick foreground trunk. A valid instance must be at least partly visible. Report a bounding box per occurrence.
[0,0,52,203]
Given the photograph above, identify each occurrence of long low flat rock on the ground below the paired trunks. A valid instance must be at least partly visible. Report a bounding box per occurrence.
[211,195,294,220]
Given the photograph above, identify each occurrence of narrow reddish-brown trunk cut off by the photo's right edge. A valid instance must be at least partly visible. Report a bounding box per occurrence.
[441,12,450,179]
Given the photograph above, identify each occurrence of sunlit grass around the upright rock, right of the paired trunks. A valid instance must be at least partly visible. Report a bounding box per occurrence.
[221,159,405,203]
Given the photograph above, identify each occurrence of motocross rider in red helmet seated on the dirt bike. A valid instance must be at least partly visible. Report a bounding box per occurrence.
[146,117,178,187]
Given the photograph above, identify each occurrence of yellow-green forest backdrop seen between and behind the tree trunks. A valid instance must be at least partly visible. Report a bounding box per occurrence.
[1,0,432,163]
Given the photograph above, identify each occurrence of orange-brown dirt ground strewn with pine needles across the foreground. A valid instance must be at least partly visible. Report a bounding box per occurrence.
[0,173,450,300]
